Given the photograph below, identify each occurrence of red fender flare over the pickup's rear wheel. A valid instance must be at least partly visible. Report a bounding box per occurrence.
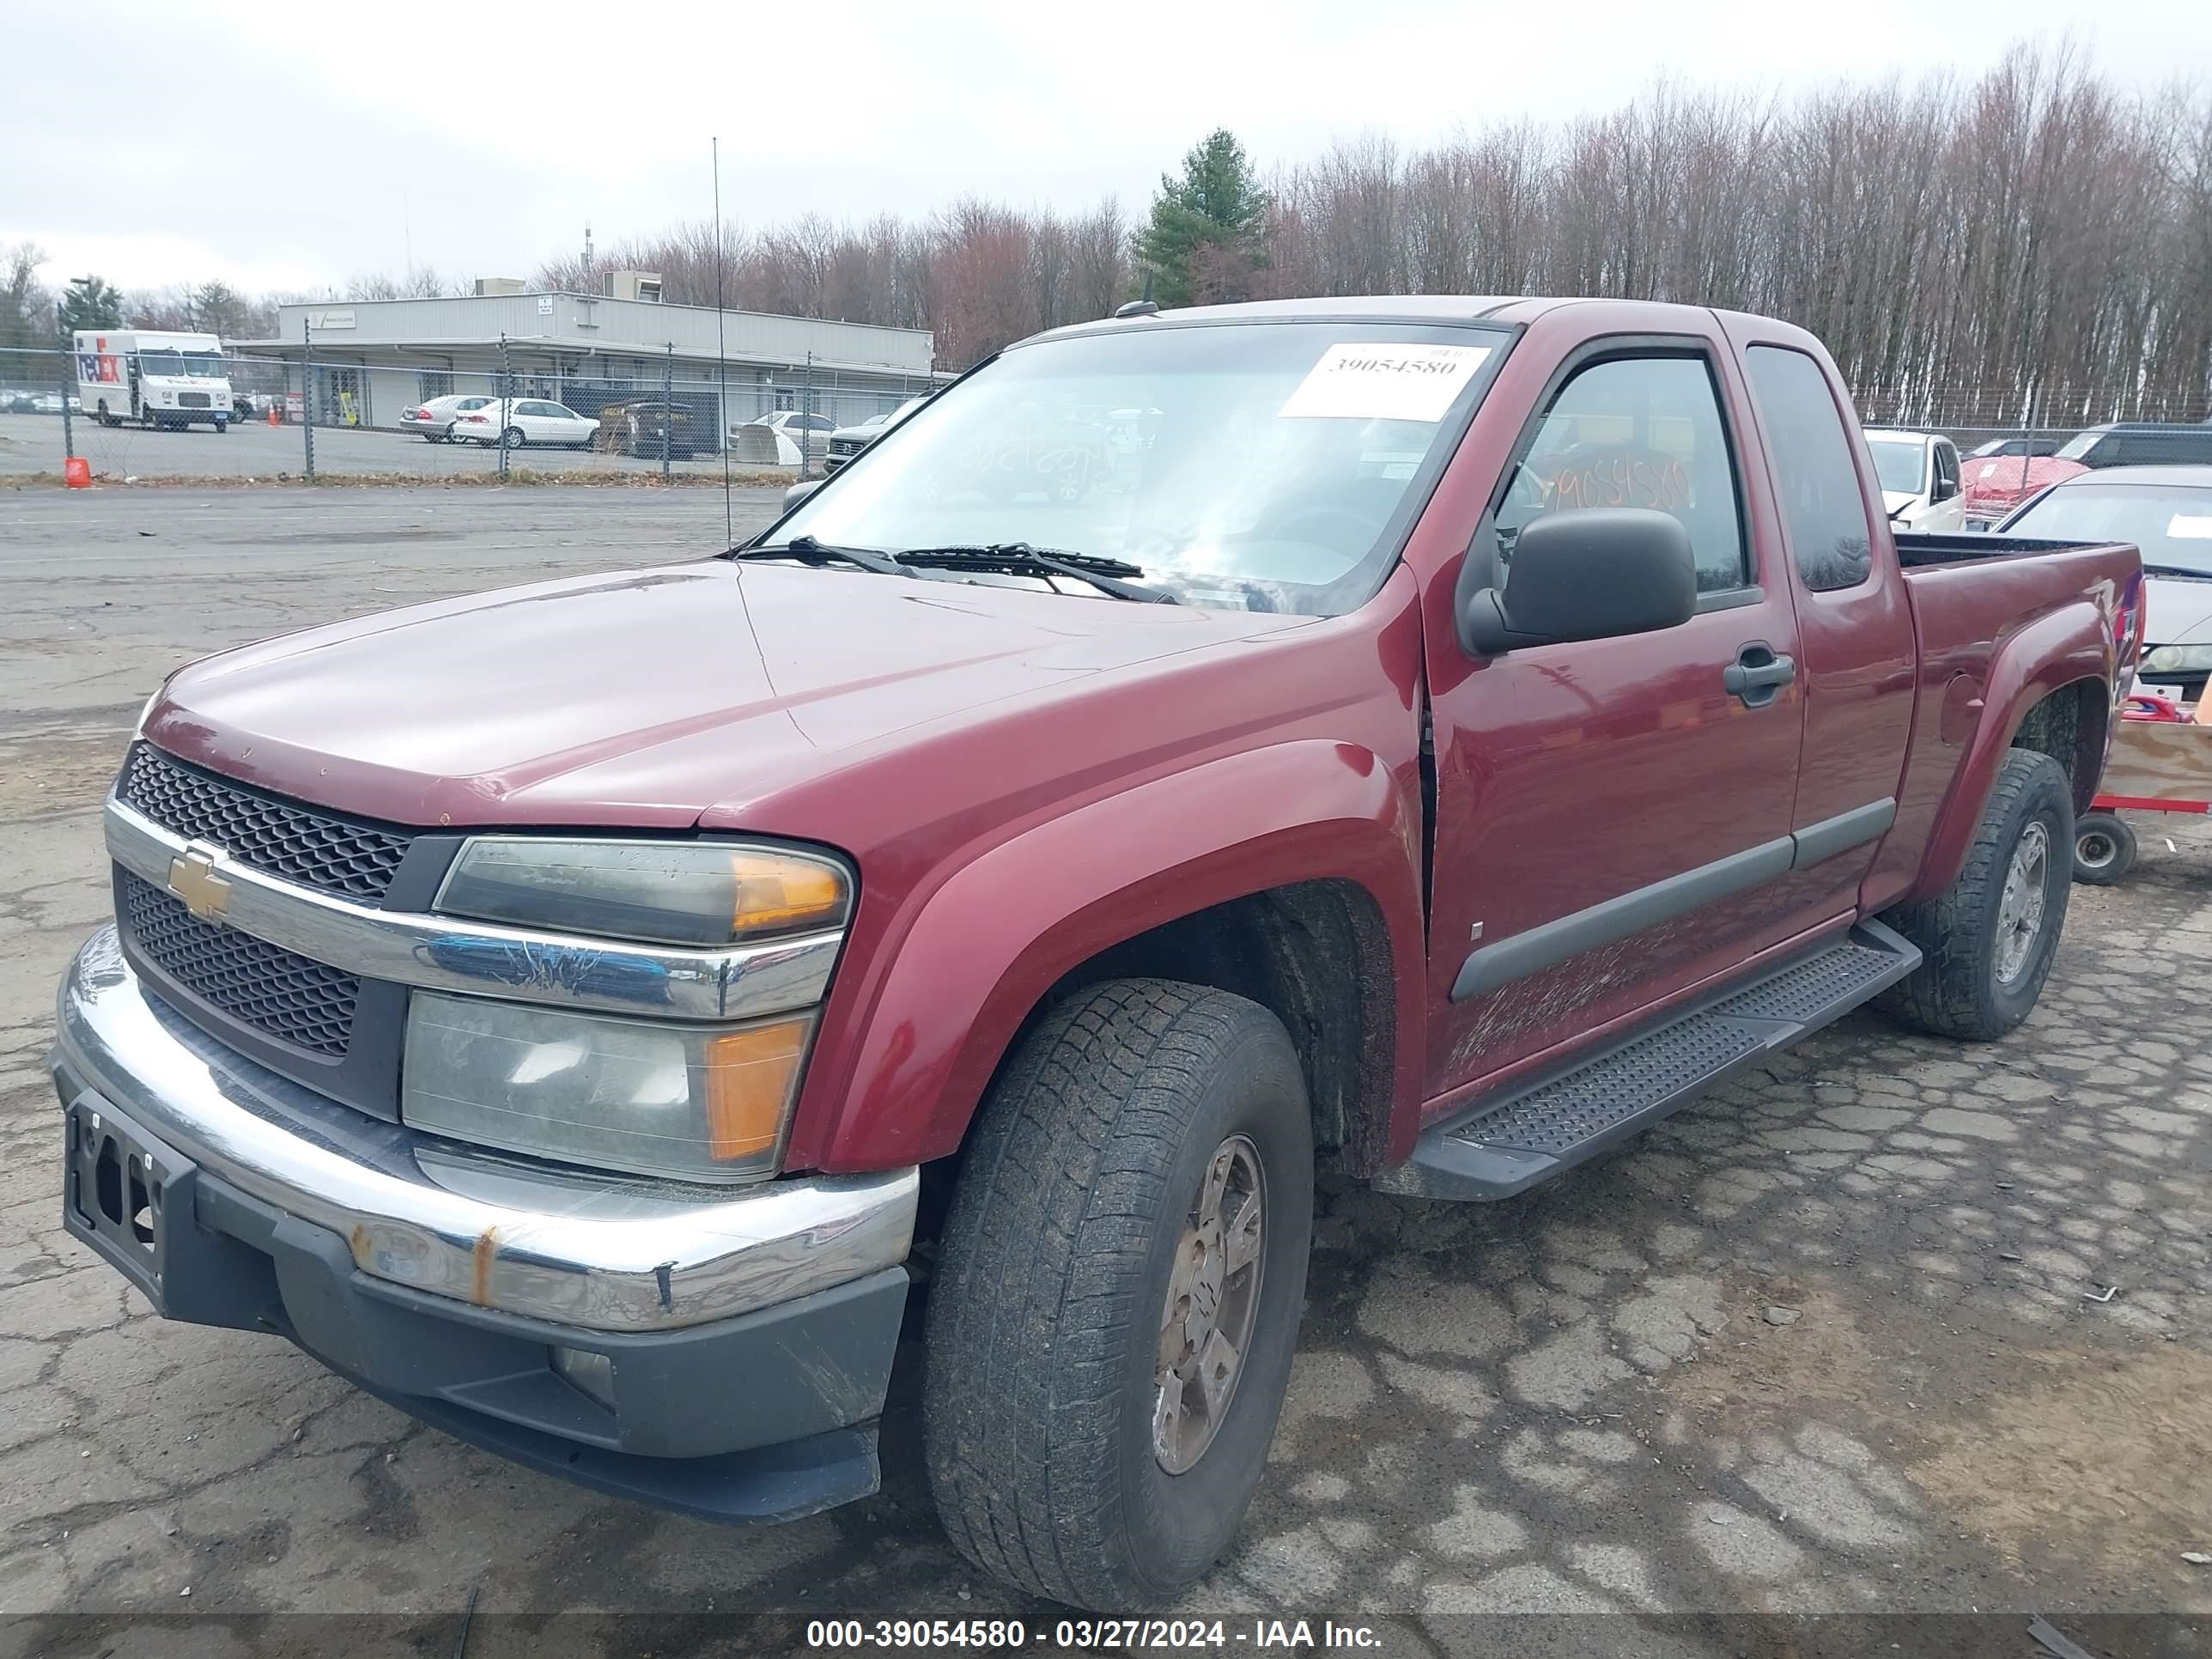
[1900,599,2115,902]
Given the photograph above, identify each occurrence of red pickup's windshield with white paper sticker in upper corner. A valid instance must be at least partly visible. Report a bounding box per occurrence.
[775,321,1506,615]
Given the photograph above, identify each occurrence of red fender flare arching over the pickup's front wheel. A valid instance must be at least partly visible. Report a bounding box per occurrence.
[785,738,1427,1170]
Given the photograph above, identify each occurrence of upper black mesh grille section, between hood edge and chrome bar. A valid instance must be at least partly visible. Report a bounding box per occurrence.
[115,744,410,905]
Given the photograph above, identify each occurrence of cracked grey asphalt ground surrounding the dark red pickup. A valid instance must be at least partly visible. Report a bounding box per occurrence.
[0,486,2212,1659]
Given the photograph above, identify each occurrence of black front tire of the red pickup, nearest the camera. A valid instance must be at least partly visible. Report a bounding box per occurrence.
[922,980,1314,1610]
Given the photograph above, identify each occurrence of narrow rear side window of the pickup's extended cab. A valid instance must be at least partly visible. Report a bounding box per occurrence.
[1743,345,1874,592]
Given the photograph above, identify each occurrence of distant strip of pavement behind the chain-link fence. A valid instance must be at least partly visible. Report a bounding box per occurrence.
[0,416,778,483]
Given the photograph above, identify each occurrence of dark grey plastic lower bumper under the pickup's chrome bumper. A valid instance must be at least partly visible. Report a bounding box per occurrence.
[55,1073,907,1522]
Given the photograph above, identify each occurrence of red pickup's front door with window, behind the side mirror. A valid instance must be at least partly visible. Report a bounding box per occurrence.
[1429,334,1802,1117]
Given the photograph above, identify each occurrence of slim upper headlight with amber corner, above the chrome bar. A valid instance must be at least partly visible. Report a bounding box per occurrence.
[438,836,852,945]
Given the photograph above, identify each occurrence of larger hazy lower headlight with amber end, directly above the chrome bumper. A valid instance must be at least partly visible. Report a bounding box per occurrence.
[400,991,814,1182]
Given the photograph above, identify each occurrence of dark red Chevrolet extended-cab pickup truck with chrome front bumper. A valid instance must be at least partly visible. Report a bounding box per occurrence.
[53,299,2142,1608]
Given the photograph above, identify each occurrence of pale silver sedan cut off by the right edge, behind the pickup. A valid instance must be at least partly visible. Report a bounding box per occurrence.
[1997,467,2212,703]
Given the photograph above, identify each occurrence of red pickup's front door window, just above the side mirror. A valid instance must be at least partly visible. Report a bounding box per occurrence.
[1493,356,1750,592]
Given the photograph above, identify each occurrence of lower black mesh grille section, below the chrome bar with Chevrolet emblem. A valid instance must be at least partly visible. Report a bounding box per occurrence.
[119,869,361,1055]
